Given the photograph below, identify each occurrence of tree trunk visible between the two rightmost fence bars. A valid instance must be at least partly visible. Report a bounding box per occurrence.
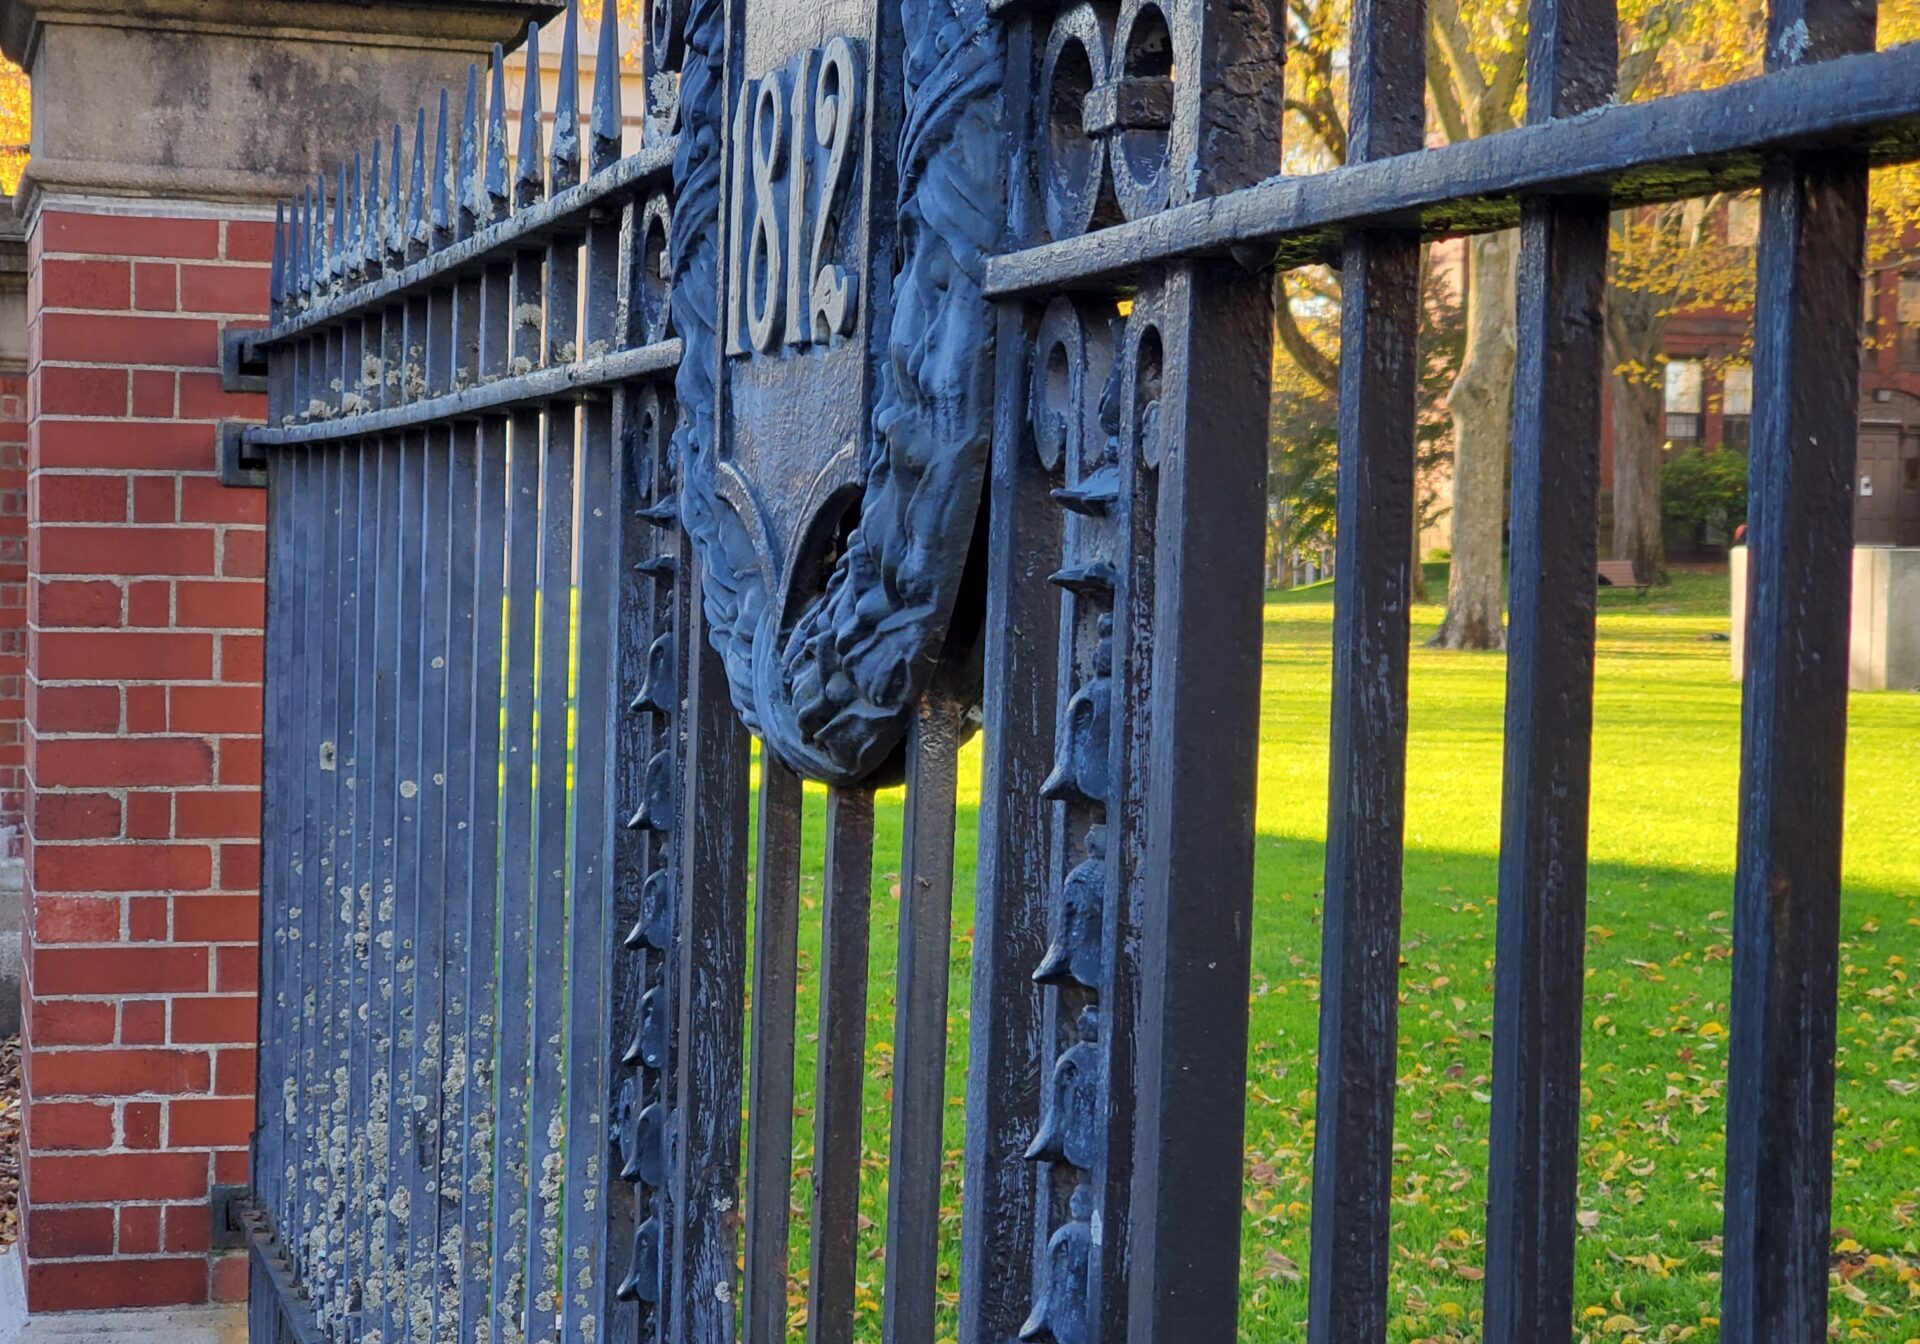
[1607,284,1668,584]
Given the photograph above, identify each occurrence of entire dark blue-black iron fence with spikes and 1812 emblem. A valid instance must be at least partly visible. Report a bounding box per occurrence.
[248,0,1920,1344]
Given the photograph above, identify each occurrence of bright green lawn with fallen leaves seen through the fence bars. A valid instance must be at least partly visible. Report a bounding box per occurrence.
[756,572,1920,1344]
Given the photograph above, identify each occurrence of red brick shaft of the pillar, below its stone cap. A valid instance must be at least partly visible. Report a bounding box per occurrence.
[20,204,271,1311]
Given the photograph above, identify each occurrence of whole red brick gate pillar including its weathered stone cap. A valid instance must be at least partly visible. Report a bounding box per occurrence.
[0,0,555,1311]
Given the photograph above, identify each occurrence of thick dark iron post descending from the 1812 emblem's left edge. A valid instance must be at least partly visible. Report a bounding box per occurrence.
[668,602,744,1344]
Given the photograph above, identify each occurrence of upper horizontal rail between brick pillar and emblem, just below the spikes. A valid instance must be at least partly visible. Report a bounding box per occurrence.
[242,138,678,351]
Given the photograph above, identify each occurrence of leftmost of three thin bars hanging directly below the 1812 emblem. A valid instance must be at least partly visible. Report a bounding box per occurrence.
[743,753,801,1344]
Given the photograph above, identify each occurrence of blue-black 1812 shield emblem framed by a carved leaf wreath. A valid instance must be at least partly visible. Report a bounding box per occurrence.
[674,0,1006,785]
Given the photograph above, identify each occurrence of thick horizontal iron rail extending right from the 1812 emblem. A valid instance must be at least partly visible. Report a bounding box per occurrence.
[987,42,1920,298]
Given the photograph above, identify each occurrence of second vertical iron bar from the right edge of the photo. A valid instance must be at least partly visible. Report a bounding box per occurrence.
[1486,0,1619,1344]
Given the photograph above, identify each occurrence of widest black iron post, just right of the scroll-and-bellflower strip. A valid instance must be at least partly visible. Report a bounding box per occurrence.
[1108,0,1282,1344]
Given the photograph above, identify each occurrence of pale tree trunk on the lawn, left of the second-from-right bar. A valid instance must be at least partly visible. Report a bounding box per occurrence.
[1432,232,1515,649]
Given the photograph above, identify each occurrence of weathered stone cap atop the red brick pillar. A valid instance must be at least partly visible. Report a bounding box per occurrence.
[0,0,564,217]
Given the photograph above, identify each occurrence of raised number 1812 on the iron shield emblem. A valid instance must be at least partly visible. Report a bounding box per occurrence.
[728,38,864,355]
